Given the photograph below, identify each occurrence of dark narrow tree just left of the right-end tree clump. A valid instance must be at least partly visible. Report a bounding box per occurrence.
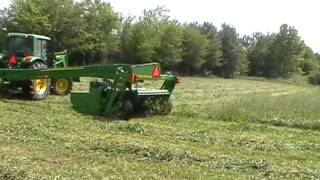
[219,24,248,78]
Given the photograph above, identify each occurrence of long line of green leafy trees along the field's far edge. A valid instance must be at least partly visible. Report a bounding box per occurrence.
[0,0,320,78]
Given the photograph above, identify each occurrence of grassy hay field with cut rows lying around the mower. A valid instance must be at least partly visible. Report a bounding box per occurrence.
[0,78,320,179]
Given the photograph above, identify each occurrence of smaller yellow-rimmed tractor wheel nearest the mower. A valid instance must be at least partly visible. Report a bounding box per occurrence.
[51,78,72,96]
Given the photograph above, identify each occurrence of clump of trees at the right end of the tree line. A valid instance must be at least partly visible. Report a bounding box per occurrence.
[244,24,319,78]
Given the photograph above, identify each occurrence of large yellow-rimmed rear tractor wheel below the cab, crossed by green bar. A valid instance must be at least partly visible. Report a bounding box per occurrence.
[22,62,50,100]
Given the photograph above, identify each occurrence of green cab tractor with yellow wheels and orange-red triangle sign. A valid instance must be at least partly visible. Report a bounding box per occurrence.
[0,33,72,100]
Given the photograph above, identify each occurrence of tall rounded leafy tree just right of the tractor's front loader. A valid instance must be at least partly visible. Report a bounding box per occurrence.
[78,0,120,63]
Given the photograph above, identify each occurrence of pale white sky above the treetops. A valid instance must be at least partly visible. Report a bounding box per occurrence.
[0,0,320,53]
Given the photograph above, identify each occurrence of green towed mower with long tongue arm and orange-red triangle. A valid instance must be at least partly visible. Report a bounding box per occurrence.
[0,63,179,119]
